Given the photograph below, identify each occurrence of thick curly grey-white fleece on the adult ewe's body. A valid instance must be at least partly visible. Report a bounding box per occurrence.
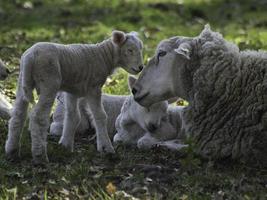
[183,30,267,166]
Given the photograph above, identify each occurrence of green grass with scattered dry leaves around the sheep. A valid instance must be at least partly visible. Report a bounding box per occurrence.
[0,0,267,200]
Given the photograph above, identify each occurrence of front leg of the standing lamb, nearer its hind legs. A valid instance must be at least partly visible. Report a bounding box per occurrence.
[59,93,80,151]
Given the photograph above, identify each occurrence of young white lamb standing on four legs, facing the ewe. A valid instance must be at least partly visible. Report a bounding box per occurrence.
[5,31,143,165]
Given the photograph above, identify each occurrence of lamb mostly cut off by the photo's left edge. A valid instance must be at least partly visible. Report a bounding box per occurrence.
[0,59,12,119]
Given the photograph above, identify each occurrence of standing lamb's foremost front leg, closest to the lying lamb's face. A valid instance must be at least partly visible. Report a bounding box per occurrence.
[87,91,115,153]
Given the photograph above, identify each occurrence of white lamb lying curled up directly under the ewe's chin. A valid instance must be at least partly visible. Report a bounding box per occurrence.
[113,77,186,150]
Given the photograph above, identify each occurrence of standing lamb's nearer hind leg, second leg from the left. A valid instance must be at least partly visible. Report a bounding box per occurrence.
[29,89,56,164]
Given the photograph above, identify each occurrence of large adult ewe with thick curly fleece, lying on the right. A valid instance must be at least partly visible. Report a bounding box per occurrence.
[132,25,267,166]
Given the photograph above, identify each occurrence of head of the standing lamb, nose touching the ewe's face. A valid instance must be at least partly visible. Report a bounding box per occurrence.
[112,31,144,74]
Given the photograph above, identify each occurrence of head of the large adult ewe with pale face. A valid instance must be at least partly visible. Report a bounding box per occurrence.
[132,26,222,107]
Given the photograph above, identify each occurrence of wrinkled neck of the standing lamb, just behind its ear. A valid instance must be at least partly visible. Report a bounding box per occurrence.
[96,39,119,74]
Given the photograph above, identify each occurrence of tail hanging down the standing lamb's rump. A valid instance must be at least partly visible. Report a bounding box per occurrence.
[20,55,34,103]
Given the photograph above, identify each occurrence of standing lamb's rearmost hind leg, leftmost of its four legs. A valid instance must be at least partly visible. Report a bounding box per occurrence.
[5,74,29,160]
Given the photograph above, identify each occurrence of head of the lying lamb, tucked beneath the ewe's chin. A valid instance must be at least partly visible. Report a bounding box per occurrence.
[128,76,168,133]
